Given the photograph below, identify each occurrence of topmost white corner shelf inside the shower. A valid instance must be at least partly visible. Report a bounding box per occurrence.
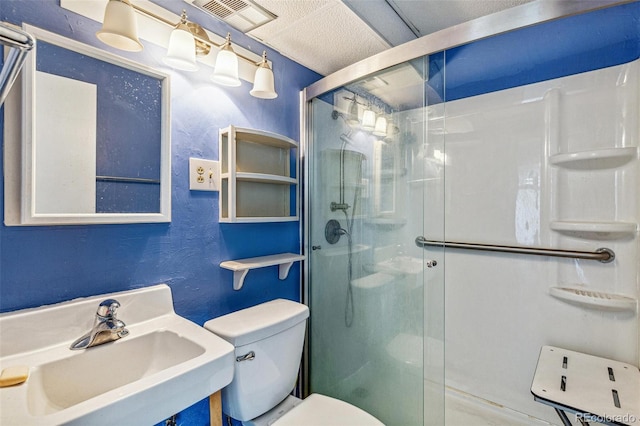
[549,146,638,170]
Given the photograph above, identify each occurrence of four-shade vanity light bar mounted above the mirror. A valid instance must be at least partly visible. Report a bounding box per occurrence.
[96,0,278,99]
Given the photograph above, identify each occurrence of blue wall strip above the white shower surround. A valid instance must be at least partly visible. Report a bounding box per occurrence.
[436,1,640,103]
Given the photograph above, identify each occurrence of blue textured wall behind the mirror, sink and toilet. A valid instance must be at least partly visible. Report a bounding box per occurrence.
[0,0,320,425]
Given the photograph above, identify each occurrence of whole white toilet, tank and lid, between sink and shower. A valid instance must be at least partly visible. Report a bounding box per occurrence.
[204,299,384,426]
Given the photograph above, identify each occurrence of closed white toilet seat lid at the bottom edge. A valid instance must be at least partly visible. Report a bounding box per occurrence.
[273,393,384,426]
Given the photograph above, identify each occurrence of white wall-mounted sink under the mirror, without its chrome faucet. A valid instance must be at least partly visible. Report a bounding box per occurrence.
[0,285,234,425]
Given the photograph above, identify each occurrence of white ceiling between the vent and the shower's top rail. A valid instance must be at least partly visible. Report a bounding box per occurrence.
[248,0,532,75]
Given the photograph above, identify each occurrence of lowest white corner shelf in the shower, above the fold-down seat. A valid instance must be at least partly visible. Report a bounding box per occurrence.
[549,287,638,312]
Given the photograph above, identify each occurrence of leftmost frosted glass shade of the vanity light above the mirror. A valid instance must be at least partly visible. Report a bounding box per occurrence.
[96,0,143,52]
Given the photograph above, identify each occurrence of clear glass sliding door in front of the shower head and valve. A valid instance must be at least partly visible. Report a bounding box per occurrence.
[305,58,445,425]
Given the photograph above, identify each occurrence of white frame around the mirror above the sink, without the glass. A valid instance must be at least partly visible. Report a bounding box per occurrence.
[4,24,171,226]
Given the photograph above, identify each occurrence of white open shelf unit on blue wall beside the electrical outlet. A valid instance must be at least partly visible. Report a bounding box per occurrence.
[219,126,299,223]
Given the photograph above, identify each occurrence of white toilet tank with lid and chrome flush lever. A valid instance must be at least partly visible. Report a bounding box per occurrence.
[204,299,309,421]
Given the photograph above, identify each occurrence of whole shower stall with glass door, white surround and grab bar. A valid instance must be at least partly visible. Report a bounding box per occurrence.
[302,1,640,425]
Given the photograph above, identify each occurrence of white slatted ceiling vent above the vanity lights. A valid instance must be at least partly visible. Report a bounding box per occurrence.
[184,0,277,33]
